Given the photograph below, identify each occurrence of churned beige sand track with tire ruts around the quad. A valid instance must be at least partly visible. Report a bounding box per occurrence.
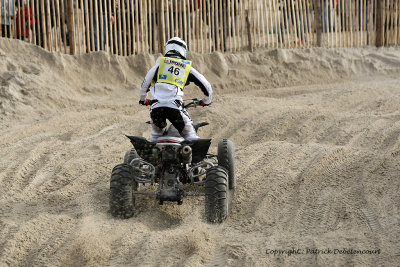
[0,39,400,266]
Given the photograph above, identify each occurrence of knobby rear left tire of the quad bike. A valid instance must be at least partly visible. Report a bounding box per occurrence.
[110,163,137,219]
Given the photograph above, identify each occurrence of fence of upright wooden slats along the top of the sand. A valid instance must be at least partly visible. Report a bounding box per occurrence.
[0,0,400,56]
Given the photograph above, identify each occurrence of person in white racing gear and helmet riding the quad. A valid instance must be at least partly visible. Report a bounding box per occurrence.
[139,37,212,142]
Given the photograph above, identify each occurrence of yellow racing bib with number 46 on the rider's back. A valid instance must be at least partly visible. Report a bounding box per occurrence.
[157,57,192,89]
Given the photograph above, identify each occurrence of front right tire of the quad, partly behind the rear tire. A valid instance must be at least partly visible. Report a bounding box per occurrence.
[218,139,236,189]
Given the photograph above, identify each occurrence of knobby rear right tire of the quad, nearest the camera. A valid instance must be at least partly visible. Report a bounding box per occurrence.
[205,166,230,223]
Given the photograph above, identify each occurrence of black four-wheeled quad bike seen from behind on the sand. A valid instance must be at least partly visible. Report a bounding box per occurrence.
[110,99,235,223]
